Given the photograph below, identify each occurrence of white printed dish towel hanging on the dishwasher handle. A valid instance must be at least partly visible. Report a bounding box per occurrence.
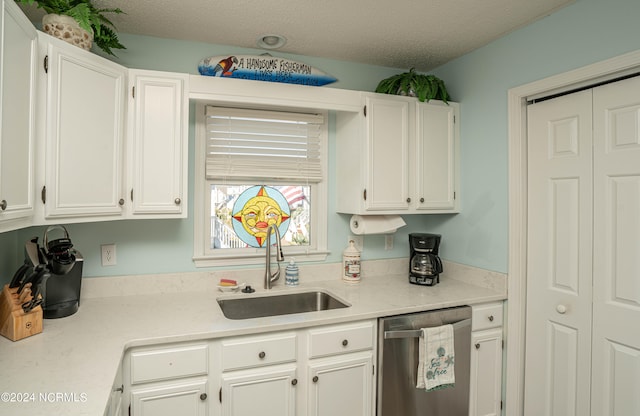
[416,325,456,391]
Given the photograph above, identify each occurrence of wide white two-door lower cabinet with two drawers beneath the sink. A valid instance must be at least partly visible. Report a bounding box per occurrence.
[211,321,376,416]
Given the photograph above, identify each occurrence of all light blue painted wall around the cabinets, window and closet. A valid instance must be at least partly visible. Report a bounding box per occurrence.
[0,0,640,280]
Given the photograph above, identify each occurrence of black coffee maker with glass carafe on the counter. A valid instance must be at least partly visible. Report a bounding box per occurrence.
[409,233,442,286]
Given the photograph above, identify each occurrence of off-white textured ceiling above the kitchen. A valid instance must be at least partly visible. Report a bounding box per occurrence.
[20,0,575,71]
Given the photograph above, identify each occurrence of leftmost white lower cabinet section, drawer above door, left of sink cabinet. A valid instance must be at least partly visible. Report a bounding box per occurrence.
[122,343,210,416]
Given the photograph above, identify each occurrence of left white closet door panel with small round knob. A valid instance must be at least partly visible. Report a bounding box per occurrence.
[524,91,592,416]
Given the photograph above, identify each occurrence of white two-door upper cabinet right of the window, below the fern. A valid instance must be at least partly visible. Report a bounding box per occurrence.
[336,94,459,214]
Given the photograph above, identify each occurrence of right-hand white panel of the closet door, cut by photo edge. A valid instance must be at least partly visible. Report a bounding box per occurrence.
[592,78,640,416]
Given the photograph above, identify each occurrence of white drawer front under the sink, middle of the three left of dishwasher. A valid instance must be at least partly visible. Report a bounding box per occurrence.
[221,332,296,371]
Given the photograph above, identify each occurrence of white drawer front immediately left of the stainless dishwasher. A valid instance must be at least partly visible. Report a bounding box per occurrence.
[308,322,374,358]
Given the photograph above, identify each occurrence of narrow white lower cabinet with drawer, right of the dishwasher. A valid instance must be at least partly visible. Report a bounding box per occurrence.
[469,302,503,416]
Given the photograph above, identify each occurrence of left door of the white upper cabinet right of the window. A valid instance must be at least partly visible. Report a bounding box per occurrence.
[364,97,410,211]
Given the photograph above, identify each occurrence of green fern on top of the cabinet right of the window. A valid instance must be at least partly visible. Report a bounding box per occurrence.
[375,68,450,104]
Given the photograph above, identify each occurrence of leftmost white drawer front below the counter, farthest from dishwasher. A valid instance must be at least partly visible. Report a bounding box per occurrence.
[131,345,209,384]
